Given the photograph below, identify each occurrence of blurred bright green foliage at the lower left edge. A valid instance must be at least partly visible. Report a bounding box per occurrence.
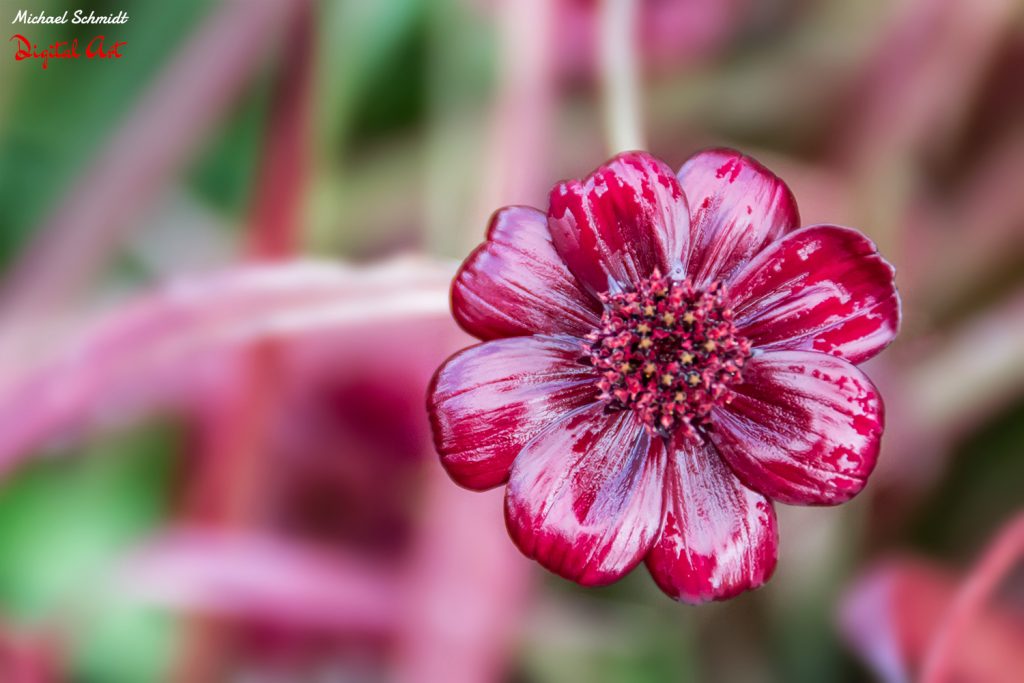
[0,428,175,683]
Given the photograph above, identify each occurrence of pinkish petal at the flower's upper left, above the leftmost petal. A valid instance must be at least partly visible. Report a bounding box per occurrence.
[452,207,600,340]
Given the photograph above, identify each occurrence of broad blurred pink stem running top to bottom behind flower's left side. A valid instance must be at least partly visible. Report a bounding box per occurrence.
[394,0,555,683]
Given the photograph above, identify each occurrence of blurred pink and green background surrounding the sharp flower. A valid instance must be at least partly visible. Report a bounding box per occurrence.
[0,0,1024,683]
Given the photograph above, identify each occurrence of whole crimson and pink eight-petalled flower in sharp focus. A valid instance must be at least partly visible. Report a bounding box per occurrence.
[428,150,900,603]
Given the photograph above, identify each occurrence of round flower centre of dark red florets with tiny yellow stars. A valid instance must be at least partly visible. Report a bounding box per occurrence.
[585,270,751,437]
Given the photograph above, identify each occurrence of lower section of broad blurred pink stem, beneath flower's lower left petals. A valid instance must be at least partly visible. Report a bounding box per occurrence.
[394,466,531,683]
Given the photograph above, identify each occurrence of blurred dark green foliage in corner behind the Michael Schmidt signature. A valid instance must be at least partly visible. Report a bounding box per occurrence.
[0,0,210,265]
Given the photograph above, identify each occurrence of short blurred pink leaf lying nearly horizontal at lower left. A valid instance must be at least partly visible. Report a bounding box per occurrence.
[109,529,401,637]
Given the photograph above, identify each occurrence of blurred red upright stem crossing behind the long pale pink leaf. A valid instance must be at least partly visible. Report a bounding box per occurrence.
[174,0,313,683]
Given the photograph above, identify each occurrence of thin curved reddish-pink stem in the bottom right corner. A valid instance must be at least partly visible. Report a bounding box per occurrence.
[921,513,1024,683]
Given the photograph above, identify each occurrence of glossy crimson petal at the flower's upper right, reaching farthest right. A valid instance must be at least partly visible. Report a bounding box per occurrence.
[729,225,900,364]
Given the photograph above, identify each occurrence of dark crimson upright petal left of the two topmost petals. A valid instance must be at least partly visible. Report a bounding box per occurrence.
[548,152,689,293]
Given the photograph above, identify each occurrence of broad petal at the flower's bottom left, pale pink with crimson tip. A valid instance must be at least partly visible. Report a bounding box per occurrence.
[505,405,665,586]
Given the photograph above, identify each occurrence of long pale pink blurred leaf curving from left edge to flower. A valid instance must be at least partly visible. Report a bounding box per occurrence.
[0,261,455,479]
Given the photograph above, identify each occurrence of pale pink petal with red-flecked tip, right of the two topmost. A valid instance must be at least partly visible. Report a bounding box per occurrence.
[679,150,800,286]
